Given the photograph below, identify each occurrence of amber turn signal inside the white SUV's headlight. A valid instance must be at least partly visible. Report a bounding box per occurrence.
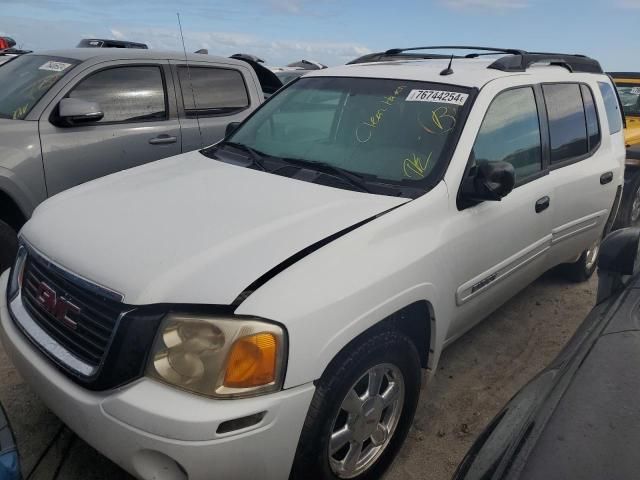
[224,332,278,388]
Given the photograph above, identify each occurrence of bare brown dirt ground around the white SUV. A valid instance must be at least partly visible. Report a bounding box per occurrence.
[0,274,597,480]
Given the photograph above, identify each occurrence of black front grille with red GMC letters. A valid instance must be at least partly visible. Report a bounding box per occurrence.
[22,255,125,367]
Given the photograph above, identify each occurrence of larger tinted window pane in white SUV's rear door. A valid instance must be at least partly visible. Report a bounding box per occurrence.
[542,83,588,163]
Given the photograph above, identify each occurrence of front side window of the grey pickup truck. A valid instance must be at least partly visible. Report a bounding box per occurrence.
[69,66,167,123]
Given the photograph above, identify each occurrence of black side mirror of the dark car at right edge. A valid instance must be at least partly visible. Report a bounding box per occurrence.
[597,228,640,303]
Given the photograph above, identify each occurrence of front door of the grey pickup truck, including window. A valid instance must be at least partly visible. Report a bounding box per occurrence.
[39,60,182,195]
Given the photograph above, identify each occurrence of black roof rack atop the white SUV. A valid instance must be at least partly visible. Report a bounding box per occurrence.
[384,45,604,73]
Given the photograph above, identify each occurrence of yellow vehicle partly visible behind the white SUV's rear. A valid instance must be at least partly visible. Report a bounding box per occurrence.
[610,72,640,227]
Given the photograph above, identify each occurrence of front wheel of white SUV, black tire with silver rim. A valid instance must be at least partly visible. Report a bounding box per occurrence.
[290,330,421,480]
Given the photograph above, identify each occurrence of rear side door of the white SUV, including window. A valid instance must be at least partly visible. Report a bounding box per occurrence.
[542,82,621,264]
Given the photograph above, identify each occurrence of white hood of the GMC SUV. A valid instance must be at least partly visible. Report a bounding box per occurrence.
[22,152,408,305]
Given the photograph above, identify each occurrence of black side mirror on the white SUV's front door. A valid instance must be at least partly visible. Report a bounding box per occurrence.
[461,160,516,205]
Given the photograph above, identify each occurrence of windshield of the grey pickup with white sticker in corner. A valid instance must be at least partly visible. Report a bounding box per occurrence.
[0,55,80,120]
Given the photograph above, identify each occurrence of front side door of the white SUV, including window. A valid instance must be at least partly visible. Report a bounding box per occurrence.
[445,83,553,341]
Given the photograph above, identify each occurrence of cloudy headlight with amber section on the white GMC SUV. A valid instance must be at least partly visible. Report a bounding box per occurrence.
[146,314,287,398]
